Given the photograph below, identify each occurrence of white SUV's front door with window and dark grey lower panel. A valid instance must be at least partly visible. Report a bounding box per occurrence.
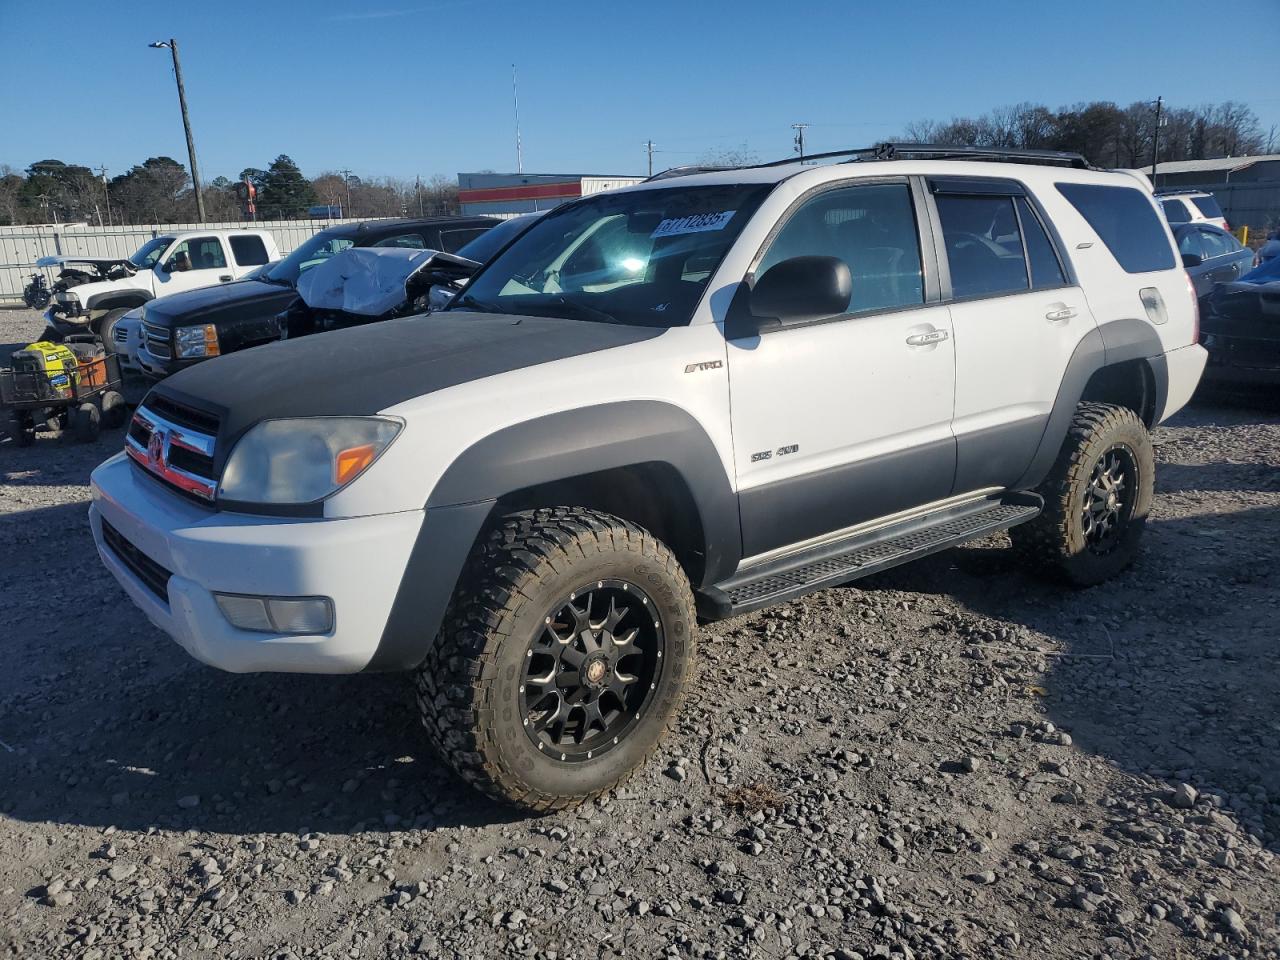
[728,178,956,558]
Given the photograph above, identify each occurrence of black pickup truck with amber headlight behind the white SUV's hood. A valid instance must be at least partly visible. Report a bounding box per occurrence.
[129,216,502,379]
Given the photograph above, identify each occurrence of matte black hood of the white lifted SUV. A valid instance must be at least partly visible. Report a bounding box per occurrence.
[154,311,663,456]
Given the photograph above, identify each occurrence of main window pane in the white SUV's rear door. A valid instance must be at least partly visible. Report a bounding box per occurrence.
[937,195,1029,297]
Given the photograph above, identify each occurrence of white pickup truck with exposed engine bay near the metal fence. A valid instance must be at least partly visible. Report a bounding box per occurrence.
[36,230,280,343]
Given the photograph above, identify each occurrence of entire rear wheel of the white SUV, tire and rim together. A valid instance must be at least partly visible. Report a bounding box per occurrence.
[1010,403,1156,586]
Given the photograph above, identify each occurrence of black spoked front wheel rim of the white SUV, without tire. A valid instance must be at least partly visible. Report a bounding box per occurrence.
[520,580,664,762]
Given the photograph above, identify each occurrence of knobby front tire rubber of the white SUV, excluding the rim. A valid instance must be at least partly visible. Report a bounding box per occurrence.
[416,507,696,813]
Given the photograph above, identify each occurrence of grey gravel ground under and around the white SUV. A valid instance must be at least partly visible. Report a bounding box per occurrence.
[0,311,1280,960]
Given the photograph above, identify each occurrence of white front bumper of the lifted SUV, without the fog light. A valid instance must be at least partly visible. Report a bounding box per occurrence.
[90,453,424,673]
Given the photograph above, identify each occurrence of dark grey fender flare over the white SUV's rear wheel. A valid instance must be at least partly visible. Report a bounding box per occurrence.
[1014,317,1169,490]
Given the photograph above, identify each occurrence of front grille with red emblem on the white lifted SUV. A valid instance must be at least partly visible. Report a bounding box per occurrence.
[124,393,219,504]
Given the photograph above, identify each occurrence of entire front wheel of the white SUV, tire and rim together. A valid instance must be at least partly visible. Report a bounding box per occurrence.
[417,507,695,812]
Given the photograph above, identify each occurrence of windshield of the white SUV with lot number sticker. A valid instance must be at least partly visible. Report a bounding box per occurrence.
[451,184,772,326]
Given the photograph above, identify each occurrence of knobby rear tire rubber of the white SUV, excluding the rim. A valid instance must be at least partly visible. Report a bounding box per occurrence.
[1010,403,1156,586]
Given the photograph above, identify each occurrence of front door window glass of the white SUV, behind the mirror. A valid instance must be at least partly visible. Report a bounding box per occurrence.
[752,183,924,314]
